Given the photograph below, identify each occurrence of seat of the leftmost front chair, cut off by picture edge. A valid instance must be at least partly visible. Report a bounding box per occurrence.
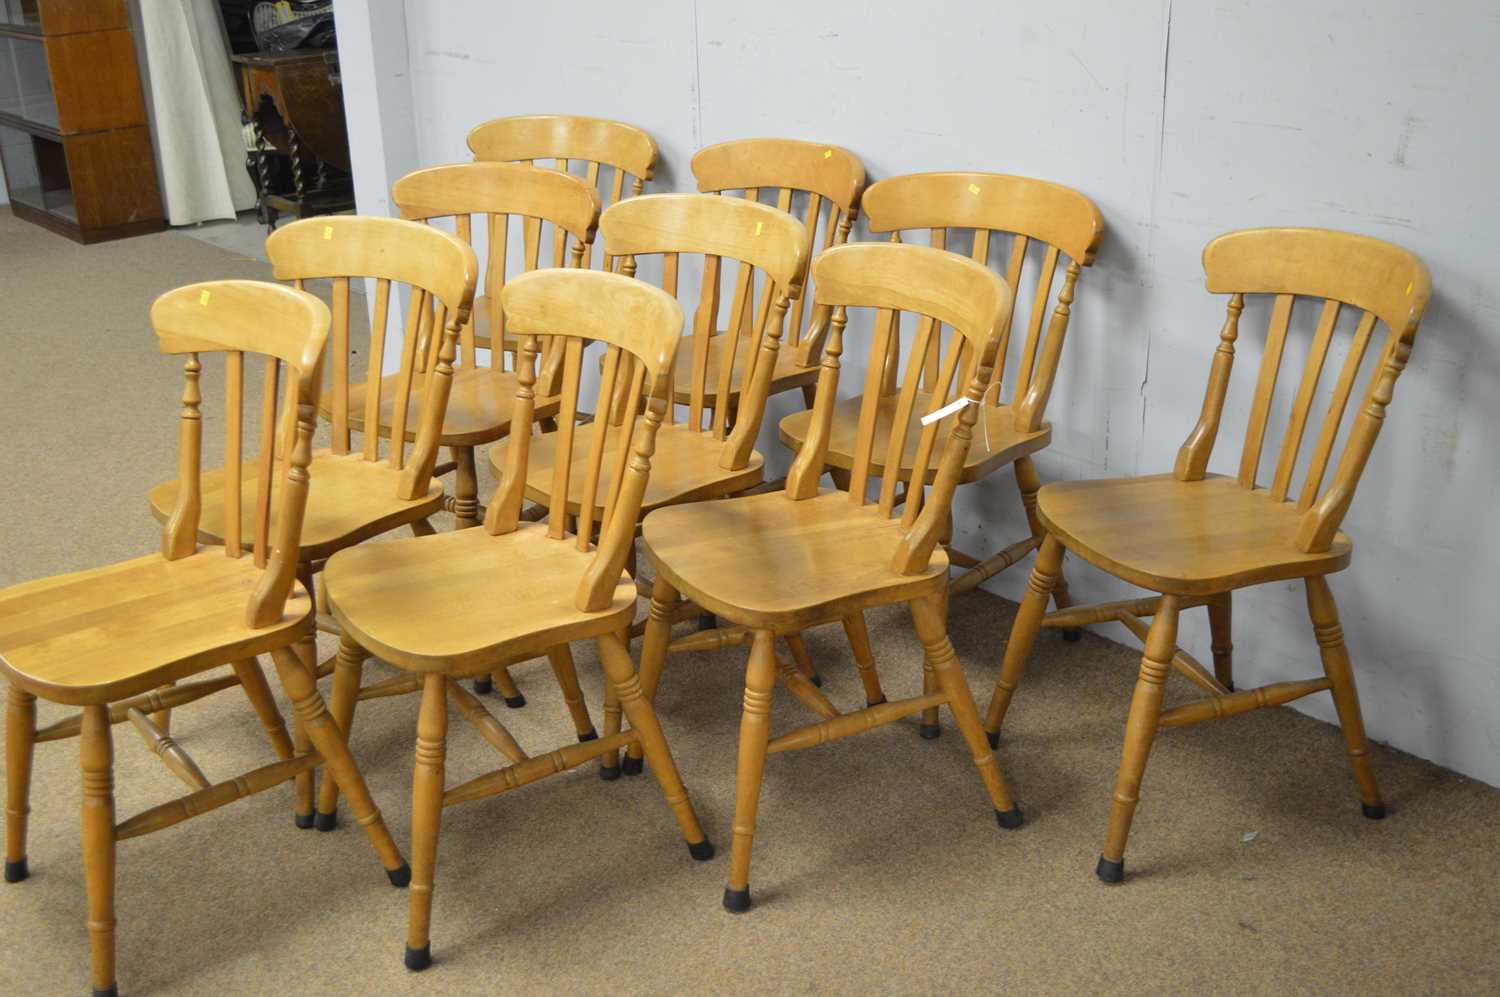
[0,547,312,706]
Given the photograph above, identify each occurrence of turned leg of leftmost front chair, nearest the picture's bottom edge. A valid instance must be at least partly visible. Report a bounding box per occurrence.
[78,705,116,997]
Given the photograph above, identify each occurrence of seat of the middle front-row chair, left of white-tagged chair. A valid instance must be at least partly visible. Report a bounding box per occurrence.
[324,523,636,675]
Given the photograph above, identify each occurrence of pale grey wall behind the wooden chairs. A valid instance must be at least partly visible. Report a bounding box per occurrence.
[339,0,1500,784]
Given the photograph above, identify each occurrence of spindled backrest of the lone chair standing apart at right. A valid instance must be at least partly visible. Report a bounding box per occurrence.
[1175,228,1431,552]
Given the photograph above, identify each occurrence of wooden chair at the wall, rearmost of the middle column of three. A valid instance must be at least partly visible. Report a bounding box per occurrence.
[675,138,864,408]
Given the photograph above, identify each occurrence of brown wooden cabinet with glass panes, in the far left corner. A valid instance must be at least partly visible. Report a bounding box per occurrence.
[0,0,164,243]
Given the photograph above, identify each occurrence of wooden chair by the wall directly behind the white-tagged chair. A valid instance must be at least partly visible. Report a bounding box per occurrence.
[779,172,1104,704]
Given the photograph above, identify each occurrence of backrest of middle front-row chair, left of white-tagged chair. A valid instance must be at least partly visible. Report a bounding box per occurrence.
[485,270,683,612]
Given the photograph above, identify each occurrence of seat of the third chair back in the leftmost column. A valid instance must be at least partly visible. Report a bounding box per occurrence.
[333,367,561,447]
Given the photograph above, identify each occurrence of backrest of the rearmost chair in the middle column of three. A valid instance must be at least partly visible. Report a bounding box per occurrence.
[693,138,864,359]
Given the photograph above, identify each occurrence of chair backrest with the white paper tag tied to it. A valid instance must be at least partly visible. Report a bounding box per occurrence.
[786,243,1011,574]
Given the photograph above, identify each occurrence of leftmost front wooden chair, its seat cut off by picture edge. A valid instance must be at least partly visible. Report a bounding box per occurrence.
[0,280,410,994]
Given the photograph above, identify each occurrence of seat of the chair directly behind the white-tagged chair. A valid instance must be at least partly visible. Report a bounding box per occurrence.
[779,391,1052,484]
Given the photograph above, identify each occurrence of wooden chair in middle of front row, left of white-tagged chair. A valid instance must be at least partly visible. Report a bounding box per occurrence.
[318,270,714,970]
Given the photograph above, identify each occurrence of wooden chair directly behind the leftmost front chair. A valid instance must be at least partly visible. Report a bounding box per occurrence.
[150,216,479,829]
